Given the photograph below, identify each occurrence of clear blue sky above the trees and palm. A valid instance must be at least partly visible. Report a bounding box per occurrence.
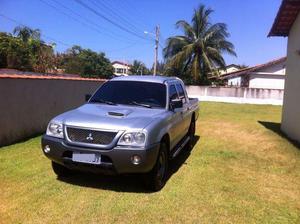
[0,0,287,66]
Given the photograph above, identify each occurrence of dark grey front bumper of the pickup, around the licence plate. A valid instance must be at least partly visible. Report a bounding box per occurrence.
[42,135,159,174]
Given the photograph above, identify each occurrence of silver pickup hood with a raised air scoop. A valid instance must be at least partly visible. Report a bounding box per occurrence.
[55,104,165,130]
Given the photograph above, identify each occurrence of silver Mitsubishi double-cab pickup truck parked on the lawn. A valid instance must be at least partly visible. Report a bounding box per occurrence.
[42,76,199,191]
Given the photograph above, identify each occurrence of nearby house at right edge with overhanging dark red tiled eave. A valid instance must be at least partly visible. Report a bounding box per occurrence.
[269,0,300,143]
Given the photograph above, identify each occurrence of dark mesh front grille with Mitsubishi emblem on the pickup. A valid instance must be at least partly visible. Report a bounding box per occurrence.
[67,127,117,145]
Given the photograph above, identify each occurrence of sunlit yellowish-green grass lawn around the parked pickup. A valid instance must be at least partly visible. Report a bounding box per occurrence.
[0,103,300,223]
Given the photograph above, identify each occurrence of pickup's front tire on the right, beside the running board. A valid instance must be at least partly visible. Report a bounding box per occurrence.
[145,142,169,191]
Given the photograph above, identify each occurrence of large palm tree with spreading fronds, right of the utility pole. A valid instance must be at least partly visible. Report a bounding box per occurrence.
[163,5,236,81]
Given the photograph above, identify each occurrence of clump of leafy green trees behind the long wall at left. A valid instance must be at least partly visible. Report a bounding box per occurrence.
[0,26,113,78]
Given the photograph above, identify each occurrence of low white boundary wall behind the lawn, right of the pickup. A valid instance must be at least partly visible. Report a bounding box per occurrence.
[186,86,284,105]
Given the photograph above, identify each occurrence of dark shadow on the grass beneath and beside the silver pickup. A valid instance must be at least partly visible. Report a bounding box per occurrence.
[58,136,200,193]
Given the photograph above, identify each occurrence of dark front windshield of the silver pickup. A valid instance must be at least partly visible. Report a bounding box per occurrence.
[89,81,166,108]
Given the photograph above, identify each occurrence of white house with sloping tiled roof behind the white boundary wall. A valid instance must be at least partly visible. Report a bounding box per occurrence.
[221,57,286,89]
